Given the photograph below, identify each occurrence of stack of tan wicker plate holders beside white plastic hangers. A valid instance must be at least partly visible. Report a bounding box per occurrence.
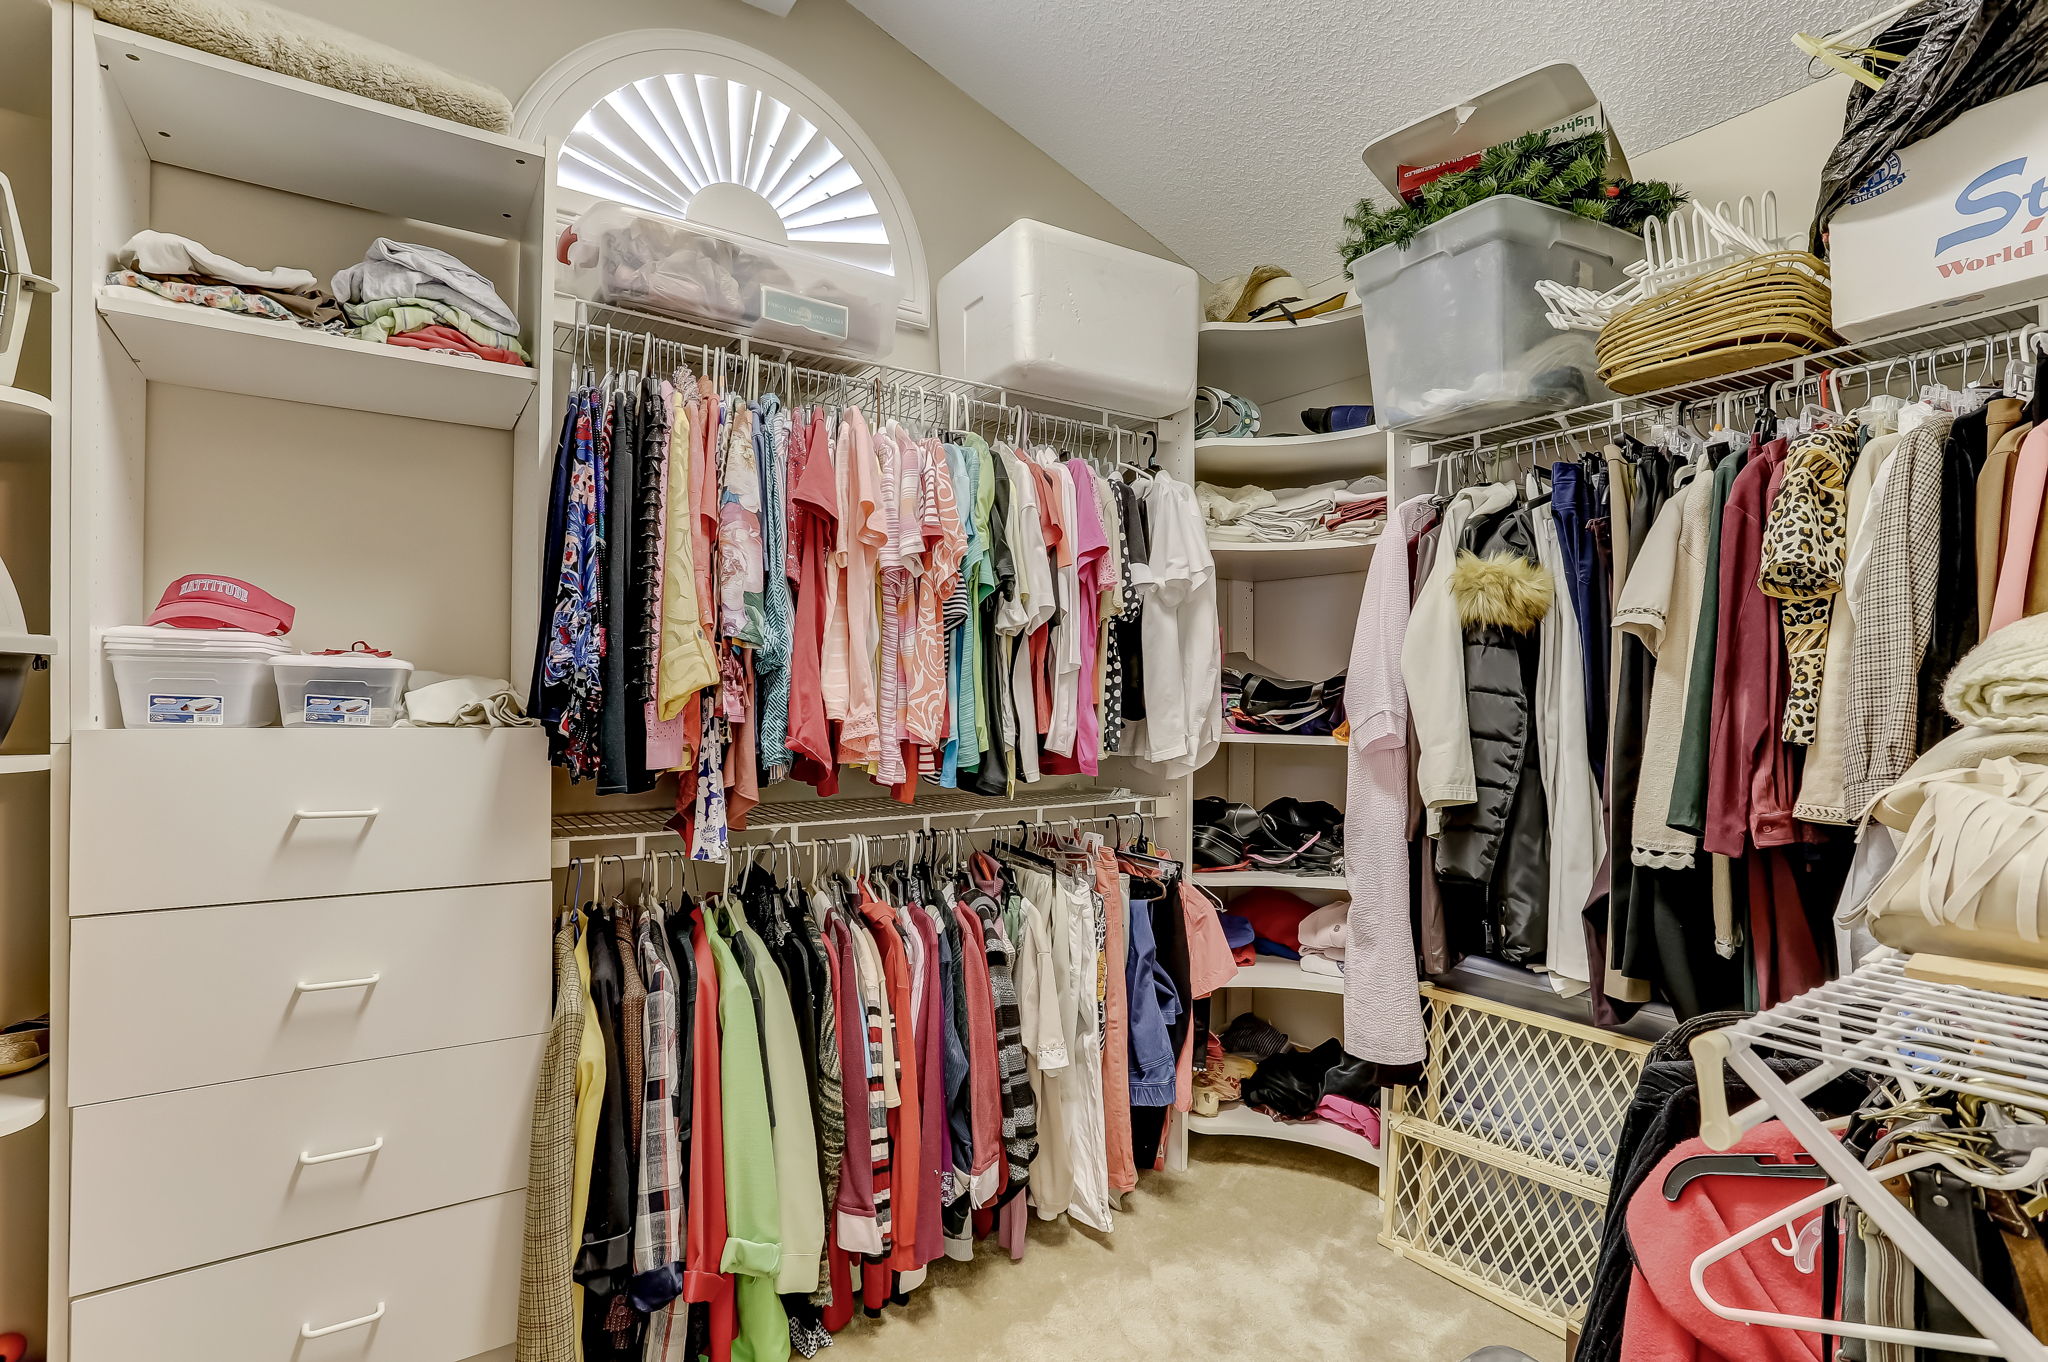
[1595,250,1841,393]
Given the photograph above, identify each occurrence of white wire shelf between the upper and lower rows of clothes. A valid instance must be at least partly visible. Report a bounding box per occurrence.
[553,789,1159,868]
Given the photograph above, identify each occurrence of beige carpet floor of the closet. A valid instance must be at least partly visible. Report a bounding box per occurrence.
[819,1137,1565,1362]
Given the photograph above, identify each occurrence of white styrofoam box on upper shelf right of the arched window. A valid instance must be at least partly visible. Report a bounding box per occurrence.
[938,217,1202,416]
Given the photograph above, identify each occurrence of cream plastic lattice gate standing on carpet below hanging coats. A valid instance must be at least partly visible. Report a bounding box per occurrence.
[1380,985,1649,1335]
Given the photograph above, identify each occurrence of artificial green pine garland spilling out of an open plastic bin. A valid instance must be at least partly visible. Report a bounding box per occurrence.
[1341,133,1686,264]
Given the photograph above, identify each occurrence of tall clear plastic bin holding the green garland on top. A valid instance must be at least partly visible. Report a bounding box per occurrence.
[1352,195,1642,436]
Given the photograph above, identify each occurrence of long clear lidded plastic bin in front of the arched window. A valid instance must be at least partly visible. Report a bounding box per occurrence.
[559,203,903,356]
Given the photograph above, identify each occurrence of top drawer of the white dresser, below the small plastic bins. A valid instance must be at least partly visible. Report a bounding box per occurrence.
[70,729,549,918]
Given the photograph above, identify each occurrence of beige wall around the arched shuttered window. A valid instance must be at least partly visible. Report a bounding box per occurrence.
[249,0,1174,369]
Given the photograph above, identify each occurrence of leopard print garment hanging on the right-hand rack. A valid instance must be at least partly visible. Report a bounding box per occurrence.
[1757,426,1855,746]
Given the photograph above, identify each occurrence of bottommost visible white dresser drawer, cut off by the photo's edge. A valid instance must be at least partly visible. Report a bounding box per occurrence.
[72,1192,526,1362]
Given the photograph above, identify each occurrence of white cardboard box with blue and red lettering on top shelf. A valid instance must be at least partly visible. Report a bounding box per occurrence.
[1827,84,2048,340]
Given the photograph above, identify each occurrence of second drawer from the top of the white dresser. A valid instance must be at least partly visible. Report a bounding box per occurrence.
[70,883,553,1106]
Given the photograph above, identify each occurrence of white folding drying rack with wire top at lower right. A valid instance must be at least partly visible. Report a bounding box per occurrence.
[1692,950,2048,1362]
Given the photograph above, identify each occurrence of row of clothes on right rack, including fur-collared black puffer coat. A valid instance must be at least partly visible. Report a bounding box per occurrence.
[1348,350,2048,1032]
